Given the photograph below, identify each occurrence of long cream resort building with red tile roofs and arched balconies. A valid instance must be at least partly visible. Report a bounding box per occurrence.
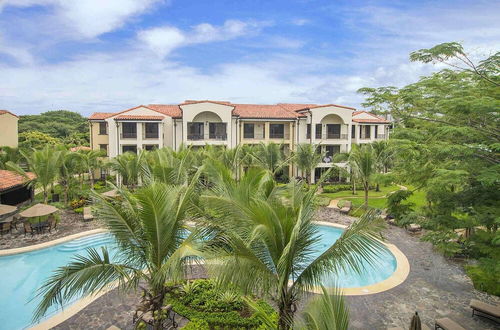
[89,100,390,179]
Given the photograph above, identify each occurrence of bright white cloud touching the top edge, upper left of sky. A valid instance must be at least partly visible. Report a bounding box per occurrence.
[0,0,162,38]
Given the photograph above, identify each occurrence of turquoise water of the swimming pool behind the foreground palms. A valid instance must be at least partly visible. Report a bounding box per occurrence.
[0,226,396,330]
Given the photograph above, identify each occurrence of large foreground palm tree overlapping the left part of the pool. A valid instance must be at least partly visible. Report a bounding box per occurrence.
[34,182,202,329]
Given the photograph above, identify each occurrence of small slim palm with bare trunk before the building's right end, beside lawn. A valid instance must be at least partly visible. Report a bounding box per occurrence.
[349,144,377,209]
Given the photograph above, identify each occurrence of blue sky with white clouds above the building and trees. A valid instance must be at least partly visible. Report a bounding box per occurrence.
[0,0,500,115]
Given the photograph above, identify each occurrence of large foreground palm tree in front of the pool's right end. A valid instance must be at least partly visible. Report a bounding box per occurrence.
[200,168,382,329]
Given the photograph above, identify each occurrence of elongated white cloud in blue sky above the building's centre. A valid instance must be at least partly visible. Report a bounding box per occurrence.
[137,20,271,57]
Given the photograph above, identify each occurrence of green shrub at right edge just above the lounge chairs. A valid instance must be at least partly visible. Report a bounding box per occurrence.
[465,258,500,296]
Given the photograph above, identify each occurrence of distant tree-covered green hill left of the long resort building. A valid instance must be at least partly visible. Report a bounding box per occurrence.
[19,110,89,142]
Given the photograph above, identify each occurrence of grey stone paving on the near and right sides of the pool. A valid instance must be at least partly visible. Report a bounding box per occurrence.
[26,208,500,329]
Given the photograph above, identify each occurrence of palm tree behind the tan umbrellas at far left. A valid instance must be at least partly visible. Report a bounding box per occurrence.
[6,145,62,203]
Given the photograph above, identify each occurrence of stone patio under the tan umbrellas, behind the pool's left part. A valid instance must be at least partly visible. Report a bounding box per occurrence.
[0,210,102,250]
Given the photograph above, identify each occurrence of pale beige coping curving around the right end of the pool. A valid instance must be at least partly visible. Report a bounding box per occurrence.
[309,221,410,296]
